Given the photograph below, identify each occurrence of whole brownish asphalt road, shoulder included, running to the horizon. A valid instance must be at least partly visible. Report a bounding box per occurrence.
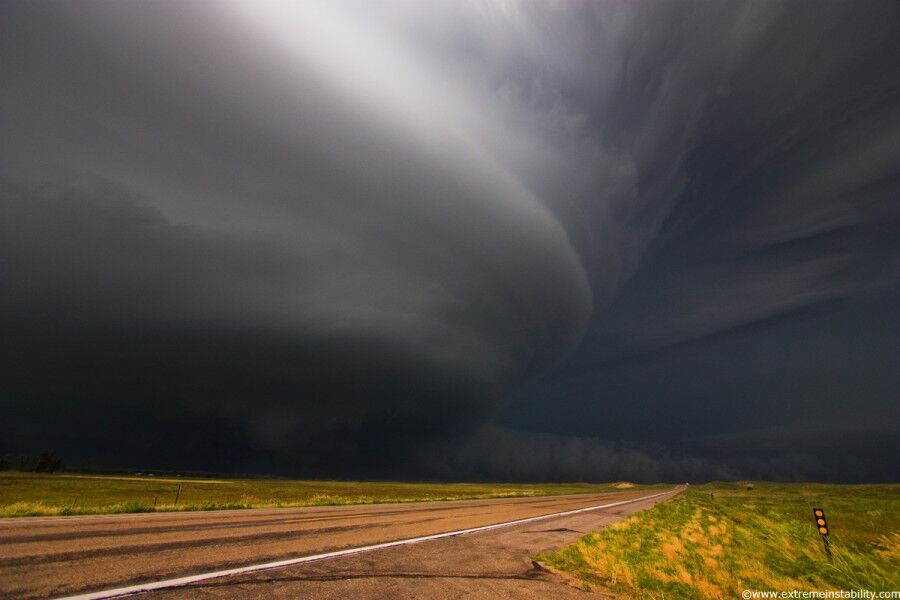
[0,488,680,599]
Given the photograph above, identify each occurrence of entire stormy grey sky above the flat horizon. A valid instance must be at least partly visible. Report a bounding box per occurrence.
[0,0,900,481]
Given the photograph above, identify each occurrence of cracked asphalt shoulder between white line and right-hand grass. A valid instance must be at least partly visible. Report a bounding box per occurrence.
[146,488,672,600]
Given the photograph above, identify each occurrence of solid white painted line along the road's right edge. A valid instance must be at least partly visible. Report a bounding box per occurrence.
[57,488,677,600]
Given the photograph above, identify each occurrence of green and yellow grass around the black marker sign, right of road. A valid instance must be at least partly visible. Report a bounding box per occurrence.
[539,483,900,599]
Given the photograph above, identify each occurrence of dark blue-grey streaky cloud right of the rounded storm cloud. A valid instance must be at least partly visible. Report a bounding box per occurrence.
[505,3,900,479]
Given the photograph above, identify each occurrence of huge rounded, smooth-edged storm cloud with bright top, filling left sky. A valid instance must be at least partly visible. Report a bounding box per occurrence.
[2,3,591,472]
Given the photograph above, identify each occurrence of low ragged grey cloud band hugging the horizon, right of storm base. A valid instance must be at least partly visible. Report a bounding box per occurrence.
[414,427,900,483]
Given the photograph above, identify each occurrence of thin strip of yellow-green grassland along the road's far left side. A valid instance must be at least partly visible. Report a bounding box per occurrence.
[0,471,665,517]
